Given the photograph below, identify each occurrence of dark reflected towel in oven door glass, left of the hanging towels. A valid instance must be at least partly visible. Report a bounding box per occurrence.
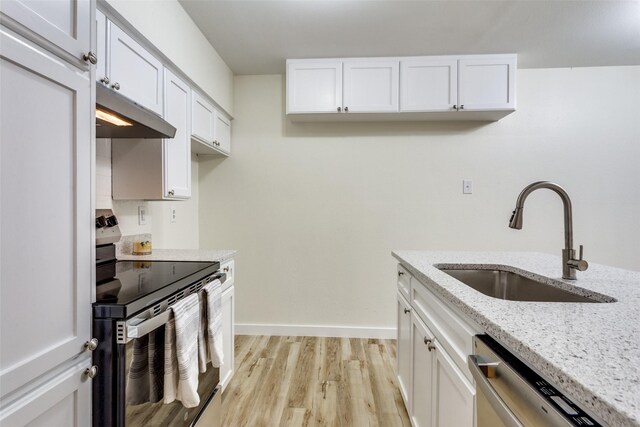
[125,326,165,405]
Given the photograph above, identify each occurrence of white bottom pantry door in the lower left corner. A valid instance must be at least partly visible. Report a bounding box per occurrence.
[0,355,91,427]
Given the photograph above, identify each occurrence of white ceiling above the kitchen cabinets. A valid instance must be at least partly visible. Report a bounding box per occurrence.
[179,0,640,74]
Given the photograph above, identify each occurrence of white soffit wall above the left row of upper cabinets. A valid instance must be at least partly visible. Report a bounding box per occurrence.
[107,0,233,115]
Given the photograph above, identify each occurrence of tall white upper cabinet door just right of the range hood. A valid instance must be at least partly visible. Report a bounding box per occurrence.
[162,70,191,199]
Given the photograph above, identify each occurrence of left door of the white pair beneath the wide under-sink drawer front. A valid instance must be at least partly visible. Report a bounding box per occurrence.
[409,312,434,427]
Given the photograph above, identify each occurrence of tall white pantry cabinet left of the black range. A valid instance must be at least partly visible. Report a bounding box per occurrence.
[0,0,95,427]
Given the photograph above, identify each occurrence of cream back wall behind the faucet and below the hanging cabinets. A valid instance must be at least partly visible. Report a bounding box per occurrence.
[200,67,640,327]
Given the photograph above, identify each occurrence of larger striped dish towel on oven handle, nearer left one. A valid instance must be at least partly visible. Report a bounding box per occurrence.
[164,294,200,408]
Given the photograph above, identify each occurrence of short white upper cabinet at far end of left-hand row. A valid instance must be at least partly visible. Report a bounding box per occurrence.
[191,91,231,155]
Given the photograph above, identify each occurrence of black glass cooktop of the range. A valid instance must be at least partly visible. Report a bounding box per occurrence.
[94,261,220,317]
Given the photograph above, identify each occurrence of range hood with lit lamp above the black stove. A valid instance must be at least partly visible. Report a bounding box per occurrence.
[96,83,176,138]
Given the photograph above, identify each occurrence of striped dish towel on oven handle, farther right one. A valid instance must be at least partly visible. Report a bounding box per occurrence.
[199,280,224,368]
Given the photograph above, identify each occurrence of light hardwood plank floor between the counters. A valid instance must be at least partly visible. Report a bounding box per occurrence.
[222,335,411,427]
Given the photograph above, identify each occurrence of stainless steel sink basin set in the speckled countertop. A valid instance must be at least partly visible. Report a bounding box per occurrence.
[440,268,603,302]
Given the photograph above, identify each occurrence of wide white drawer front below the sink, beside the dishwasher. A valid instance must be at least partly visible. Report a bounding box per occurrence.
[411,277,482,381]
